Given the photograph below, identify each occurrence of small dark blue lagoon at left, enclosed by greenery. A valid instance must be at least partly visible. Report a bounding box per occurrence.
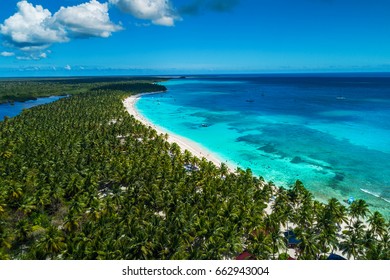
[0,96,63,121]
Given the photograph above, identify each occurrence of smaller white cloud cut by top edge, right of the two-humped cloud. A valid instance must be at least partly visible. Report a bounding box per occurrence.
[109,0,180,26]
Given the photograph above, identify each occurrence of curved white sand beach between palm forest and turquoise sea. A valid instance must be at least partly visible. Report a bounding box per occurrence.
[123,91,237,171]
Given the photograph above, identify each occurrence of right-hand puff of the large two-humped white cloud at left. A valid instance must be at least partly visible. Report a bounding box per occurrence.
[53,0,122,38]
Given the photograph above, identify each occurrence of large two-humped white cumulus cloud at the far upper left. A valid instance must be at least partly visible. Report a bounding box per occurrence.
[0,0,122,59]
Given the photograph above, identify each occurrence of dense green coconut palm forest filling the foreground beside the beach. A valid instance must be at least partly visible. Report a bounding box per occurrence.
[0,80,390,259]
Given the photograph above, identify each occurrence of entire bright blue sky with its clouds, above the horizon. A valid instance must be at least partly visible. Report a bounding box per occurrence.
[0,0,390,77]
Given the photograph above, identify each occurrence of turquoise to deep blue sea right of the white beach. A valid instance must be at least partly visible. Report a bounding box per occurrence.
[136,75,390,218]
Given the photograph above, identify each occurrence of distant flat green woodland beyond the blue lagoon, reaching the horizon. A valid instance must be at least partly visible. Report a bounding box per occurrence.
[0,77,165,104]
